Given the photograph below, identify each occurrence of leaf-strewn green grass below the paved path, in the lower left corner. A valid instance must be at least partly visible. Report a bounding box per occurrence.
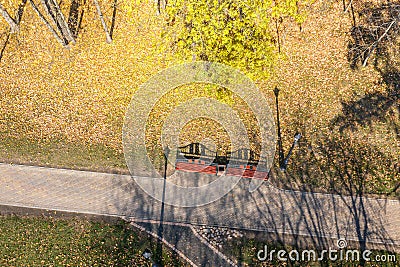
[0,216,184,266]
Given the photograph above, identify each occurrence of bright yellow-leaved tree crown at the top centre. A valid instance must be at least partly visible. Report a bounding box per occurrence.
[159,0,305,78]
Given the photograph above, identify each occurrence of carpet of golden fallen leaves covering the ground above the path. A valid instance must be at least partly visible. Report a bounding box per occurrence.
[0,0,400,197]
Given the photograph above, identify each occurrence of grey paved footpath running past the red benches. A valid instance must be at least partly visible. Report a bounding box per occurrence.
[0,163,400,266]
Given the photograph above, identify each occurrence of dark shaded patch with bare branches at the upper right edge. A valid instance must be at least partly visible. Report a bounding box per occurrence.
[332,1,400,140]
